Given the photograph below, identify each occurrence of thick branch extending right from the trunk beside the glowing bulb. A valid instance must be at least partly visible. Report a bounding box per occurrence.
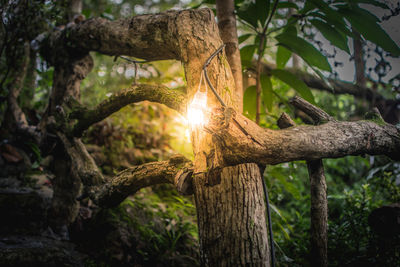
[208,109,400,168]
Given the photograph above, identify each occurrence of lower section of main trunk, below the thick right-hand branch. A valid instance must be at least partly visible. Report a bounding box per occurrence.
[193,163,269,266]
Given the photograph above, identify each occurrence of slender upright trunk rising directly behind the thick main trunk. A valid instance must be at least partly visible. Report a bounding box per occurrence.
[216,0,243,113]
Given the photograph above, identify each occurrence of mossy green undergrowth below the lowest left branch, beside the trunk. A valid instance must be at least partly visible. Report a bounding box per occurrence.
[81,185,199,266]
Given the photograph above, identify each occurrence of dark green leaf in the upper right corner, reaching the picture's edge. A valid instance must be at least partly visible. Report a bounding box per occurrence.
[340,6,400,56]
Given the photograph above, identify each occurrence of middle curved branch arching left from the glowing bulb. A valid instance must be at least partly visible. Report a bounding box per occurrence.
[70,84,186,137]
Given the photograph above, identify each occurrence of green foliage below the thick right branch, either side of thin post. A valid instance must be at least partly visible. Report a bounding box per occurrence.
[264,157,400,266]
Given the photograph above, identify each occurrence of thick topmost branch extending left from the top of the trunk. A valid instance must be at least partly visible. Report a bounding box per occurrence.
[41,8,213,62]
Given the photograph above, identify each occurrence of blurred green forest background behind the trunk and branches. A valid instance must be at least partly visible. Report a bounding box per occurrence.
[0,0,400,266]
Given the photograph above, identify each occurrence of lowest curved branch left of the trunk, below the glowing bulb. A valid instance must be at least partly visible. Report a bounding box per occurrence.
[89,155,193,207]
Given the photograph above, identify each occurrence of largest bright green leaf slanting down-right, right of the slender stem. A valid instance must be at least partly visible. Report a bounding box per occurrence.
[275,33,331,72]
